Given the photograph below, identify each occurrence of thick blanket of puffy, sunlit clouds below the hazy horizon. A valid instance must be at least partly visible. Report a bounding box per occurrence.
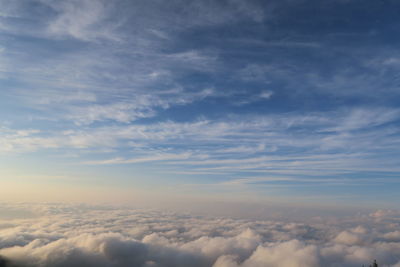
[0,204,400,267]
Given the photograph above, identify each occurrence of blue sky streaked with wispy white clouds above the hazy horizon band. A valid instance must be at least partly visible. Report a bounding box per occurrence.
[0,0,400,206]
